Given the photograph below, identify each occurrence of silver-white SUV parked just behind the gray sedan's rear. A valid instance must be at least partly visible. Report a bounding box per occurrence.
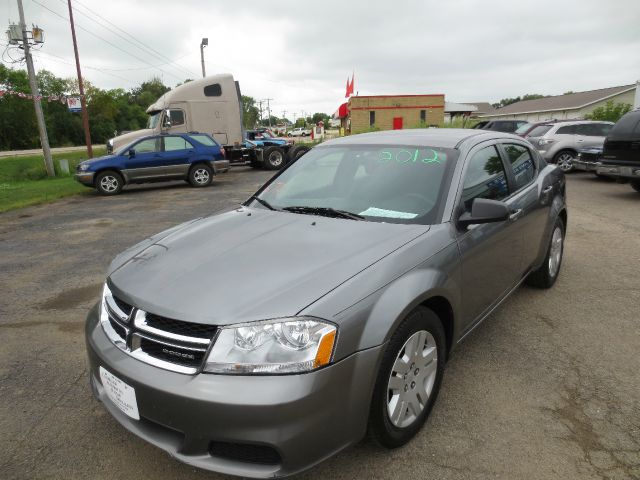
[527,120,613,173]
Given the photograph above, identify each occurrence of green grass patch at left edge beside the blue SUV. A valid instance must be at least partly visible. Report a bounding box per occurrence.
[0,149,105,212]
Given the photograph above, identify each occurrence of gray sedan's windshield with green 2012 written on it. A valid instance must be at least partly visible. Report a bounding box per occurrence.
[256,145,458,224]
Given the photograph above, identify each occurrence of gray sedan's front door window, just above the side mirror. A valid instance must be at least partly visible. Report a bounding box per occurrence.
[462,146,509,211]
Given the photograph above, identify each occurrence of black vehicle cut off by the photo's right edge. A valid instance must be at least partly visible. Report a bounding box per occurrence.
[597,108,640,192]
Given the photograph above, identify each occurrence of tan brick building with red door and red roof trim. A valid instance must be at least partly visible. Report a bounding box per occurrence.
[334,94,444,133]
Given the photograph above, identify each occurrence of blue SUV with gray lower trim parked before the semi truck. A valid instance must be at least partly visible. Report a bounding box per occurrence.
[75,132,229,195]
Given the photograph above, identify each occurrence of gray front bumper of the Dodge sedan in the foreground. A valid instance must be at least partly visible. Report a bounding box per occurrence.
[86,308,384,478]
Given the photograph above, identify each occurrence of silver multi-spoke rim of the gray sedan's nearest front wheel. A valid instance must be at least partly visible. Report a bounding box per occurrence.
[387,330,438,428]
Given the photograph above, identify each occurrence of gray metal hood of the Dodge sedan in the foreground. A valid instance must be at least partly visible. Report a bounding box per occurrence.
[108,207,429,325]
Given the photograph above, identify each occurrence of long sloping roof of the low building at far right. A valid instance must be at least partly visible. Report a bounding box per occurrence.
[485,84,636,117]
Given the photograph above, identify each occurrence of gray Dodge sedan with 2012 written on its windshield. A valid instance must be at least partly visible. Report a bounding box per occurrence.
[86,129,567,478]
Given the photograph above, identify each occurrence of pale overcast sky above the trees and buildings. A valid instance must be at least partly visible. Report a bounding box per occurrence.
[0,0,640,118]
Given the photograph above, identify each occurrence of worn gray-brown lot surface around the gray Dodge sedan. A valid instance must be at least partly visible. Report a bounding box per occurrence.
[0,168,640,480]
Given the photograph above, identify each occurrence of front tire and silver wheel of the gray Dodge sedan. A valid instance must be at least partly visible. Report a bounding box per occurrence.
[369,307,447,448]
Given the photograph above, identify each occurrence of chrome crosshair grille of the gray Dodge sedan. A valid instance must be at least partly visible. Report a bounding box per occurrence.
[100,288,217,374]
